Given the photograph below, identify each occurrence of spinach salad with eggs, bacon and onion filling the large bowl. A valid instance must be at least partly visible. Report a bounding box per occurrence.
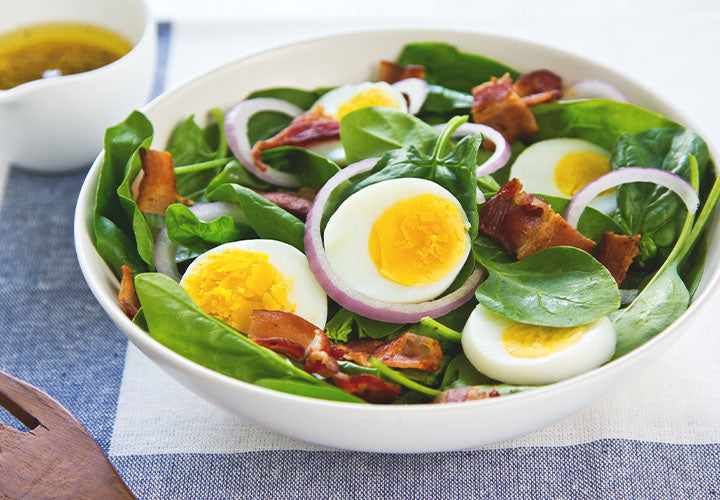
[93,42,720,404]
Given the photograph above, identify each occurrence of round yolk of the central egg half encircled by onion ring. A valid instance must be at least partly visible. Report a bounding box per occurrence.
[368,194,467,286]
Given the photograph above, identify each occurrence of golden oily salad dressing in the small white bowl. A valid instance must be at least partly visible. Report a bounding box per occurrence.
[0,23,132,90]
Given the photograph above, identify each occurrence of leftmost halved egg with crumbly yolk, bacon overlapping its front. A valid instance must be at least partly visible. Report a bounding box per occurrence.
[180,239,327,332]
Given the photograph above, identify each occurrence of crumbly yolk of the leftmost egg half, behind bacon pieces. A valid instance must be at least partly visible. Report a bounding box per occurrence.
[183,249,295,332]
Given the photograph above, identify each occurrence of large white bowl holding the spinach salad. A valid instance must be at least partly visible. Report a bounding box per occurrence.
[75,30,720,452]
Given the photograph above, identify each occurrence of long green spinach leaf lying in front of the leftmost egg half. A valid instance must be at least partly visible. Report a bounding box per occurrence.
[135,273,362,401]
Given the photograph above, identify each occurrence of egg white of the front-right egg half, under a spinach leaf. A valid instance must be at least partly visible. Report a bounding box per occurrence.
[462,305,616,385]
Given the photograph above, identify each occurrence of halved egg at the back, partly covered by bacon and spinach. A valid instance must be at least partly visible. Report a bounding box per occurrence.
[308,82,408,163]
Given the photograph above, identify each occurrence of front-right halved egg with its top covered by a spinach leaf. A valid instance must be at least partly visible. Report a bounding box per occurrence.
[462,305,617,385]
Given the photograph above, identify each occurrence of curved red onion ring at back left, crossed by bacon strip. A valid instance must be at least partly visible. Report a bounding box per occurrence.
[225,97,303,187]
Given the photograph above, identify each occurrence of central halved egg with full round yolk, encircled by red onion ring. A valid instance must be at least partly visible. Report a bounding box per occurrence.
[324,178,470,303]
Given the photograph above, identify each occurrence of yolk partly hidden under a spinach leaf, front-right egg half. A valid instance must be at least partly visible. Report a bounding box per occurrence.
[502,323,586,358]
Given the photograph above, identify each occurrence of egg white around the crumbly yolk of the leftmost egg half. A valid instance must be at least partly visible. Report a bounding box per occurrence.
[180,239,327,328]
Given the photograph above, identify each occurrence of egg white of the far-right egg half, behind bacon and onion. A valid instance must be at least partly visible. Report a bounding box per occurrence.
[510,138,617,215]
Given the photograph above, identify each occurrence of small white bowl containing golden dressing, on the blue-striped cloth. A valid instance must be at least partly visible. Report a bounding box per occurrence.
[0,0,157,172]
